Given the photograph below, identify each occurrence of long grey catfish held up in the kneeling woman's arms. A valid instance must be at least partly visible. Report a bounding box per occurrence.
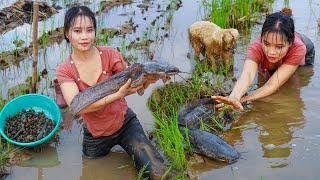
[69,62,180,115]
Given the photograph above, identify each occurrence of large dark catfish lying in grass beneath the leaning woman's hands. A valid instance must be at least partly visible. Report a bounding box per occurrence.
[178,98,239,163]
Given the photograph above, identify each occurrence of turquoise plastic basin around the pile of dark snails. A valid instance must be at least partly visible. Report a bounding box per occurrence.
[0,94,61,147]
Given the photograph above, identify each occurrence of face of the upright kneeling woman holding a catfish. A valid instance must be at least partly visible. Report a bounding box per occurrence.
[67,16,95,52]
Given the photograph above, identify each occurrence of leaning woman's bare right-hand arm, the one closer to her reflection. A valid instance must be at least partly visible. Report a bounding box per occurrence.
[241,64,298,102]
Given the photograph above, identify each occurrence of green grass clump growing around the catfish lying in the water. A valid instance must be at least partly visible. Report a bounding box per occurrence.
[148,57,239,176]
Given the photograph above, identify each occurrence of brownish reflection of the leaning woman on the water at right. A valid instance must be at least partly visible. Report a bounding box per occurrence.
[247,66,313,168]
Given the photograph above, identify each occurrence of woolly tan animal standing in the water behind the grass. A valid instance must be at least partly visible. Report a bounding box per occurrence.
[189,21,239,70]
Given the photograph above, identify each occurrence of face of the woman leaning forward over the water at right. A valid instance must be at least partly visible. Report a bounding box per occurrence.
[262,32,290,63]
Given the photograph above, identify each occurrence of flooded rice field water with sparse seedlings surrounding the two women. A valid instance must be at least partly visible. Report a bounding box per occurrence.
[0,0,320,180]
